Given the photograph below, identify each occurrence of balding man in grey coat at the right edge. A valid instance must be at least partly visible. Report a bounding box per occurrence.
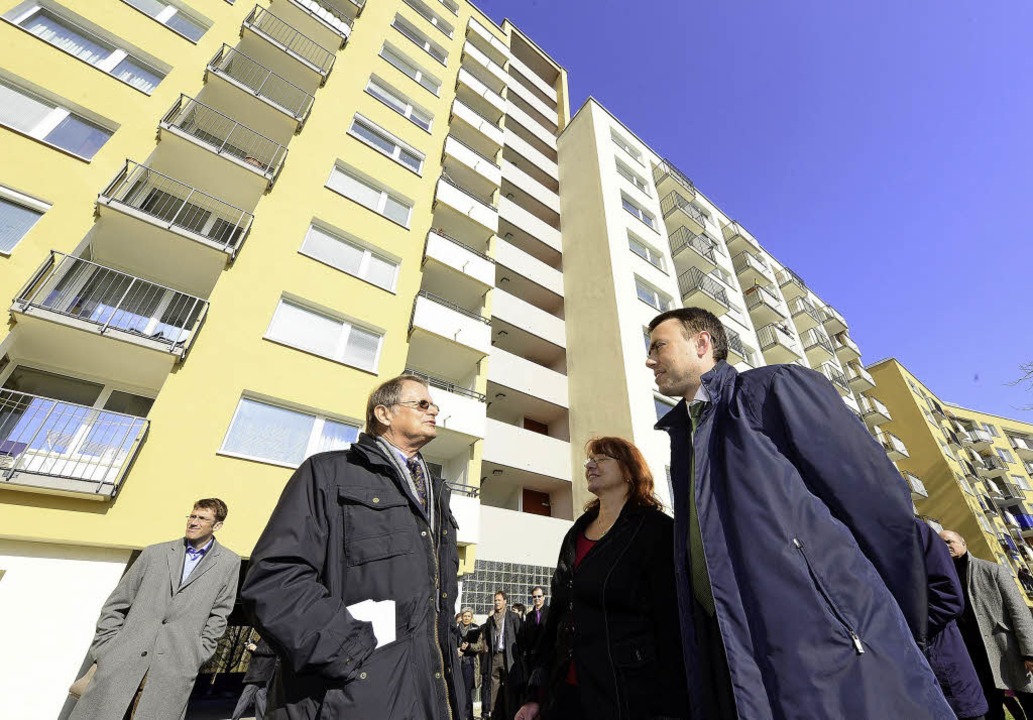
[940,530,1033,720]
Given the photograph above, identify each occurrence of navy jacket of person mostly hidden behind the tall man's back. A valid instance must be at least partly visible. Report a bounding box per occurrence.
[916,521,989,718]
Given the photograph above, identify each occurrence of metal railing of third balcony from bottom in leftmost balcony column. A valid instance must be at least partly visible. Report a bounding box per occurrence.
[100,160,254,255]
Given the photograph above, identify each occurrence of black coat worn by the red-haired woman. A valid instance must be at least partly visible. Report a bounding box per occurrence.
[529,505,688,720]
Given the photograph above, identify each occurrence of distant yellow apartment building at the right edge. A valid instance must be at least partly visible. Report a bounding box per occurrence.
[868,357,1033,605]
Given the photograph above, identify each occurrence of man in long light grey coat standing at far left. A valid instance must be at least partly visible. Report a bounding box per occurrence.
[71,498,241,720]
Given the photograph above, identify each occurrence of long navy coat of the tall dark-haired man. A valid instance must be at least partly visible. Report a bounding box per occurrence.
[657,362,953,720]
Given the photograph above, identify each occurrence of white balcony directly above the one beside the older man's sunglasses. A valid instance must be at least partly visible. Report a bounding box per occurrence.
[409,291,492,377]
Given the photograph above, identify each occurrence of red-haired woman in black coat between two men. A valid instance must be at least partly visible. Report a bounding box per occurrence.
[517,437,689,720]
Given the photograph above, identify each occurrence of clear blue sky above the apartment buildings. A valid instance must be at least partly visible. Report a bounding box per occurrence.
[475,0,1033,421]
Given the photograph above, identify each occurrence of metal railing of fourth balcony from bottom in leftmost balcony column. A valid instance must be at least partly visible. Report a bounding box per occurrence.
[161,95,287,183]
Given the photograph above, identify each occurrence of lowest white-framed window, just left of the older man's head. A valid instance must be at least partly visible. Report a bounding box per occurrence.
[221,398,358,467]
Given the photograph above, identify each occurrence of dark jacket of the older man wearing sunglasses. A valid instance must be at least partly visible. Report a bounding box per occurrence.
[242,434,463,720]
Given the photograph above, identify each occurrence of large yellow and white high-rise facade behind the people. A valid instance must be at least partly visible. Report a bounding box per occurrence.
[0,0,913,717]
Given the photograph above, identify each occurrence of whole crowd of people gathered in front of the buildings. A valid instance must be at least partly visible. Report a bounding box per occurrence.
[66,308,1033,720]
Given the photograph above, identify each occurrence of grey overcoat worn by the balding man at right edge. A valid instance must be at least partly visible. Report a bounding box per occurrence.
[964,553,1033,692]
